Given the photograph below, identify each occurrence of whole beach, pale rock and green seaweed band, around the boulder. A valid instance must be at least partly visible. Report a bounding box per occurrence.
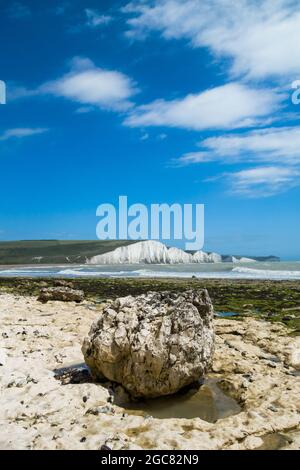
[0,278,300,450]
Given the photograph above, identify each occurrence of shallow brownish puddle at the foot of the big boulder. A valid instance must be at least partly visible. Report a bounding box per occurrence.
[122,378,241,423]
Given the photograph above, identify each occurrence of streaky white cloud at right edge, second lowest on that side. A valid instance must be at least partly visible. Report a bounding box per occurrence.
[178,127,300,165]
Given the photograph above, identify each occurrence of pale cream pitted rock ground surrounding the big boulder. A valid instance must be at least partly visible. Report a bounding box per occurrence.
[0,281,300,449]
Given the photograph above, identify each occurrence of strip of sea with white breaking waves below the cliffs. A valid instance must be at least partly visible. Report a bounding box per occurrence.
[0,261,300,280]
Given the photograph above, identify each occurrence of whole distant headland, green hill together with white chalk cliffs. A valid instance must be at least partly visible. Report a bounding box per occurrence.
[0,240,280,265]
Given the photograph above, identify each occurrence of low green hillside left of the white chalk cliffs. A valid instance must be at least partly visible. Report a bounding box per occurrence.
[0,240,134,265]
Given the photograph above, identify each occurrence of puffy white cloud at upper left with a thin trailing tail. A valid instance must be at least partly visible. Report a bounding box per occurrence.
[11,57,138,111]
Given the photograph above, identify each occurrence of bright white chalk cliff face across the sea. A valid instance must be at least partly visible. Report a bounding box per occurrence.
[87,240,222,264]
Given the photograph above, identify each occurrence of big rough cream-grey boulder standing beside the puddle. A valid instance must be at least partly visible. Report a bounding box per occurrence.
[82,289,214,397]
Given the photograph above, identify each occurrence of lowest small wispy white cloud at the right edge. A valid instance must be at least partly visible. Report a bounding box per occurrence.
[223,166,300,198]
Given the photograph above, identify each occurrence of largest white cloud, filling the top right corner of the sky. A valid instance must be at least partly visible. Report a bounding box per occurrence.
[123,0,300,78]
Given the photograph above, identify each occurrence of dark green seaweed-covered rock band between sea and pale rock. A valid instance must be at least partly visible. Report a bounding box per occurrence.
[0,276,300,335]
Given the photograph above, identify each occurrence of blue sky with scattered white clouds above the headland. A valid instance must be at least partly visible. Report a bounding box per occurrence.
[0,0,300,259]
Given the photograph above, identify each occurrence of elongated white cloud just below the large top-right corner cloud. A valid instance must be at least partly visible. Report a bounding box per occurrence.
[125,83,282,130]
